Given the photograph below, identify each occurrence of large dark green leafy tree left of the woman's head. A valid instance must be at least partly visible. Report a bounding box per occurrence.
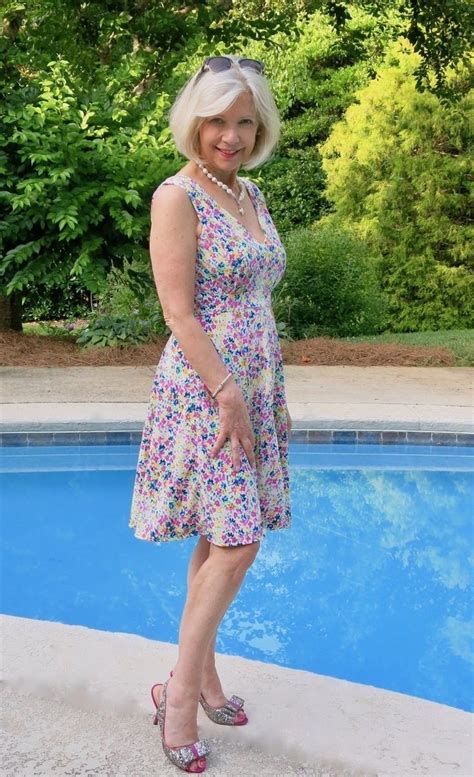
[0,0,300,327]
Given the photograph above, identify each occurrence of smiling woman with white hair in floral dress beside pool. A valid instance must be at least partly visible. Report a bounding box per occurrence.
[130,56,291,772]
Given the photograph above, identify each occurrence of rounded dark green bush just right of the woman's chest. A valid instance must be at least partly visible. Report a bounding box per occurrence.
[272,221,385,338]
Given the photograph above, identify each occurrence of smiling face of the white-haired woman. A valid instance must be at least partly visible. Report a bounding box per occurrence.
[199,92,258,173]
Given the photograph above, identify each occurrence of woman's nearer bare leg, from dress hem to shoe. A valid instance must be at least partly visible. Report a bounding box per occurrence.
[156,542,259,747]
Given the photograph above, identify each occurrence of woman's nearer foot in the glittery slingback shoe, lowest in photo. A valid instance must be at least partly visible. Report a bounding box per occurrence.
[152,677,206,772]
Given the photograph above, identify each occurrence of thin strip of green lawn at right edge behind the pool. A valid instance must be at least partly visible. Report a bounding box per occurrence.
[341,329,474,367]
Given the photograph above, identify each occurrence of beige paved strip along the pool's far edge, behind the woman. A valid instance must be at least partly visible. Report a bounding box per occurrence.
[0,366,474,432]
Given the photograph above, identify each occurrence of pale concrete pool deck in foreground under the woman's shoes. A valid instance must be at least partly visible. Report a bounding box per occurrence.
[2,616,473,777]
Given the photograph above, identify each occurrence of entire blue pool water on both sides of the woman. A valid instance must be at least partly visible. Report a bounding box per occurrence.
[0,444,474,709]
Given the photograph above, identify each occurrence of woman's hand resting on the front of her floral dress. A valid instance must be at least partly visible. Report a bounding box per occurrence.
[211,378,255,473]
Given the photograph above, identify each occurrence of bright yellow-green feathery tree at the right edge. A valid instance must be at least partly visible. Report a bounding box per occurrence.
[320,41,474,331]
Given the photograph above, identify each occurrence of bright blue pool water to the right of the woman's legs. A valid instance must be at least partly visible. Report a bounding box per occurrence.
[220,468,474,708]
